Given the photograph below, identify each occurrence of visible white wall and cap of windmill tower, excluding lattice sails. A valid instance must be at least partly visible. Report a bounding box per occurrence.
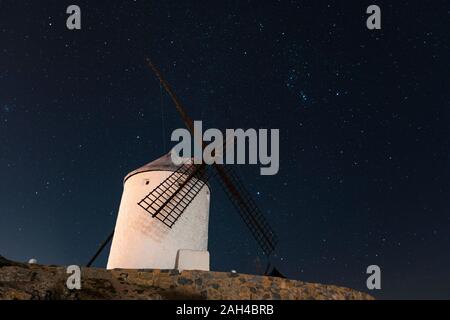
[107,153,210,270]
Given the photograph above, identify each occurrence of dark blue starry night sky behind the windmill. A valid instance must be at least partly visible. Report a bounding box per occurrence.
[0,0,450,299]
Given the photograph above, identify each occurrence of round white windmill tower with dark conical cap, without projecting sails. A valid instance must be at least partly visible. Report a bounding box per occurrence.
[107,154,210,270]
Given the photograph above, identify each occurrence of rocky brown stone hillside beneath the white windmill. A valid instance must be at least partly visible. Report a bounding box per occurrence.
[0,256,372,300]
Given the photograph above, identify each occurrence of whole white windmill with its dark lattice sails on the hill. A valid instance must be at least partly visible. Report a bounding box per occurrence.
[88,60,278,270]
